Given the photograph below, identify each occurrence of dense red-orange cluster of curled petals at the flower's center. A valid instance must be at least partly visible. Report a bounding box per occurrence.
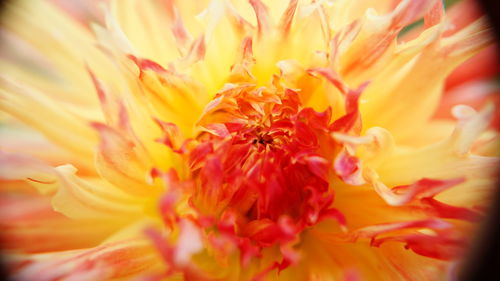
[189,83,340,243]
